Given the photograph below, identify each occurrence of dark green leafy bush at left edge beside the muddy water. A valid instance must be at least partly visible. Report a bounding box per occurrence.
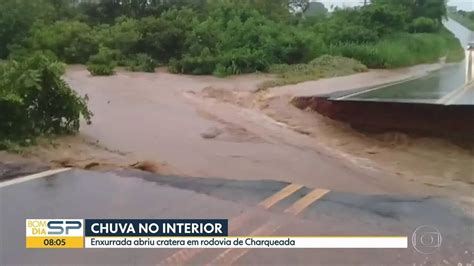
[0,54,92,145]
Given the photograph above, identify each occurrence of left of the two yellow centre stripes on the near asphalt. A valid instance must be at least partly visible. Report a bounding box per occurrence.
[158,184,303,265]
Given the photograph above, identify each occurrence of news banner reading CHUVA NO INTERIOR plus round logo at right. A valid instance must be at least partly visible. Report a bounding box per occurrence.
[26,219,441,250]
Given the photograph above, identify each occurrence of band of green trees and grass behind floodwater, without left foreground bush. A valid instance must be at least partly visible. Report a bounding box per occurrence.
[0,0,459,76]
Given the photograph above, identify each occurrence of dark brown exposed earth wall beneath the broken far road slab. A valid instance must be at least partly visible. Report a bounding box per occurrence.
[291,96,474,142]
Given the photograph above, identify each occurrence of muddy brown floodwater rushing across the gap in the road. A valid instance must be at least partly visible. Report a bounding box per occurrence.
[2,65,474,202]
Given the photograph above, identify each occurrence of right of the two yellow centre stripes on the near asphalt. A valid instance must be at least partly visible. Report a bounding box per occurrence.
[208,189,329,265]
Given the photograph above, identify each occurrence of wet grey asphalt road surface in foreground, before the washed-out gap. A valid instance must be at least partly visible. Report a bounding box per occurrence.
[0,170,474,265]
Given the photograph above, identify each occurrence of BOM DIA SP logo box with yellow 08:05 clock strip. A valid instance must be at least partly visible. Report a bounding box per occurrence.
[26,219,84,248]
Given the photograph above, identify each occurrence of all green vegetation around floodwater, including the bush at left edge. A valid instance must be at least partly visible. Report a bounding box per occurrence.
[0,0,462,150]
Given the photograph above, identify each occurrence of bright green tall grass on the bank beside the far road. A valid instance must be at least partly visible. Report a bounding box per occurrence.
[330,30,463,68]
